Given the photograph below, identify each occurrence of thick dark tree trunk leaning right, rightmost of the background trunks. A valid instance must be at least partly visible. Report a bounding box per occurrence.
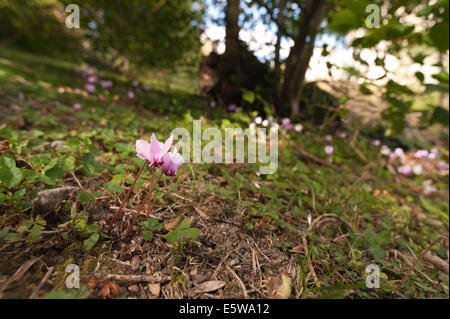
[281,0,327,116]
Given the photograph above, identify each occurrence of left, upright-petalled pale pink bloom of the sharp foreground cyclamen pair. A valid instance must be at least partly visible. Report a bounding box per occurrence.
[136,134,173,167]
